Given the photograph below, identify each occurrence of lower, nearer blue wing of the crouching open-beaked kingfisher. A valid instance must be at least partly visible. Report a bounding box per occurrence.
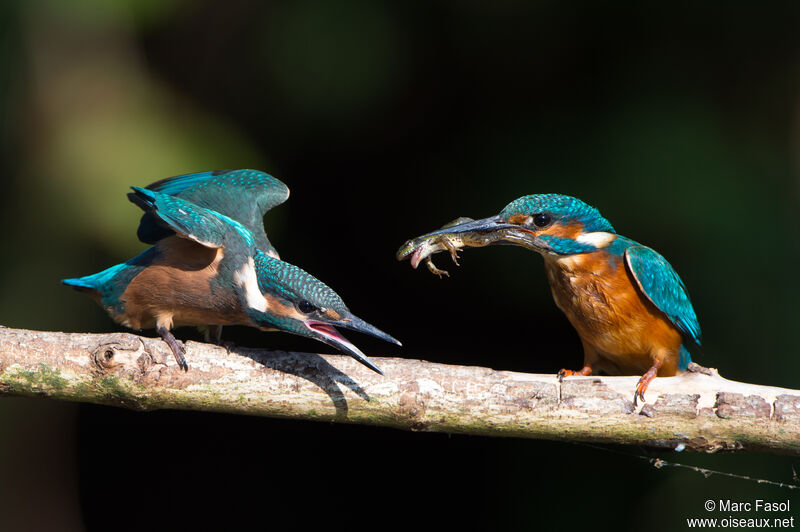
[128,187,254,248]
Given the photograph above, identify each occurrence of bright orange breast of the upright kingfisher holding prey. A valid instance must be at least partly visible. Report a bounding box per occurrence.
[545,250,681,376]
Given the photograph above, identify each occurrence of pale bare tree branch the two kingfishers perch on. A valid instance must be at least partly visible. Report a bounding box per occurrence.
[0,327,800,455]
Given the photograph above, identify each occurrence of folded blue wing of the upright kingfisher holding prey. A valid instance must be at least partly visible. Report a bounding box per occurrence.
[625,245,700,345]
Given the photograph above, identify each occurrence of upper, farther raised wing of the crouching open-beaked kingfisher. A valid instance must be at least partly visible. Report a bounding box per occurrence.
[137,170,289,252]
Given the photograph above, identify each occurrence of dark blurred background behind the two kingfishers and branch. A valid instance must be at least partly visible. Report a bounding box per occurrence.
[0,0,800,531]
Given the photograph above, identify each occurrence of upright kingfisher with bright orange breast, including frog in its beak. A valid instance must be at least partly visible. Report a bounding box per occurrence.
[398,194,705,405]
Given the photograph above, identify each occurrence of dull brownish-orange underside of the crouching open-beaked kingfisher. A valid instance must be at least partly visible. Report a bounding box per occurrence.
[115,237,246,329]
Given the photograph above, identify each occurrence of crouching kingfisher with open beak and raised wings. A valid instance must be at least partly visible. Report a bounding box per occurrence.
[62,170,401,375]
